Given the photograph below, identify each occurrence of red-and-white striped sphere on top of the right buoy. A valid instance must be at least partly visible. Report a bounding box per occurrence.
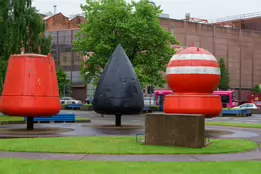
[166,47,220,94]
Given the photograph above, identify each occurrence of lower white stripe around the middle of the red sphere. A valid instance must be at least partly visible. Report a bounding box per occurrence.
[166,66,220,75]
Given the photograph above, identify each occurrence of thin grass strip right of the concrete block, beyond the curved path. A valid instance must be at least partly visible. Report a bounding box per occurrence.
[206,122,261,129]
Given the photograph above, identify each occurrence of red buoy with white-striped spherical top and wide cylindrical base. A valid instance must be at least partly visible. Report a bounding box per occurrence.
[164,47,222,118]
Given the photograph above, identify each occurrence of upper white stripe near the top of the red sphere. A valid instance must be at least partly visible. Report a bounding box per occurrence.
[170,54,217,62]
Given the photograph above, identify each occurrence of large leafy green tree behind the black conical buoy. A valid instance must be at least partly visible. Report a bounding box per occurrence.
[74,0,178,87]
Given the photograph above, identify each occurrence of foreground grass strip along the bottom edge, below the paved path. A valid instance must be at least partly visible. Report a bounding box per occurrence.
[0,159,261,174]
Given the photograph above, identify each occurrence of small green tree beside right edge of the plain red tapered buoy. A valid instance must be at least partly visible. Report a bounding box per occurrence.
[56,67,71,96]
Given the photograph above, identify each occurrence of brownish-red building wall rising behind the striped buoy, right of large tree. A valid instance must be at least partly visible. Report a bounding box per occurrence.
[161,19,261,88]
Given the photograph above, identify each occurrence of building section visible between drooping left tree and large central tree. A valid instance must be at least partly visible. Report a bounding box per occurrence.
[44,13,87,101]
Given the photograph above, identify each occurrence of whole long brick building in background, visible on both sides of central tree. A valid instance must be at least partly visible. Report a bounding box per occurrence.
[44,13,261,100]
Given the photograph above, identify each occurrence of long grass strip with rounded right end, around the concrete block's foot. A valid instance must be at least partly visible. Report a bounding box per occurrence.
[0,136,258,154]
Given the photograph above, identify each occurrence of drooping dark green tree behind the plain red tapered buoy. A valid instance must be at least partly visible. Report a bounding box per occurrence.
[0,0,51,93]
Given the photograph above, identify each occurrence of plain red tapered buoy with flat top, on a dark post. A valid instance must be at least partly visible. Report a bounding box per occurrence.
[0,54,61,117]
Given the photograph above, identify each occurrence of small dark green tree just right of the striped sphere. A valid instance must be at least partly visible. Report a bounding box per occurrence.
[218,58,230,90]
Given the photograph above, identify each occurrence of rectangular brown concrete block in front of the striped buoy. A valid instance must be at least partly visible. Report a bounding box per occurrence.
[145,113,205,148]
